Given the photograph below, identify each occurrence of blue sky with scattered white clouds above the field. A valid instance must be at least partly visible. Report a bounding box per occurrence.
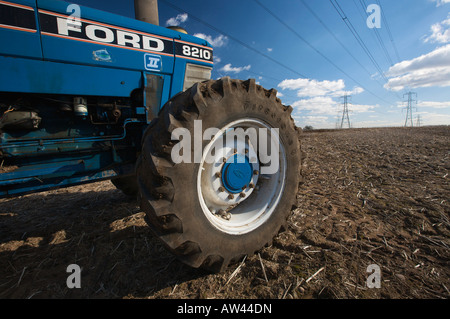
[68,0,450,128]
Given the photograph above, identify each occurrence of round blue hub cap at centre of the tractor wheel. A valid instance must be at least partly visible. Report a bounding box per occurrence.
[222,154,253,194]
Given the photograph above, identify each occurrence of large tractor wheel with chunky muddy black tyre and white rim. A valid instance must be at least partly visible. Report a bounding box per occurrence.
[136,77,301,272]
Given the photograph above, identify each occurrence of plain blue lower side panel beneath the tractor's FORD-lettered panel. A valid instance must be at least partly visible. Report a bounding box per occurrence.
[0,56,142,97]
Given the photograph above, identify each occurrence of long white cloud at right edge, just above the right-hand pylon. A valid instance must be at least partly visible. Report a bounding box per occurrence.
[384,44,450,91]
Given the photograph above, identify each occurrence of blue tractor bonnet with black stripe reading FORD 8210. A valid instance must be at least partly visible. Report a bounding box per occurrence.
[0,0,212,97]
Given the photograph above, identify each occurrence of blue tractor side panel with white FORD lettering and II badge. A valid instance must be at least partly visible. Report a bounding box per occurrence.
[38,0,174,74]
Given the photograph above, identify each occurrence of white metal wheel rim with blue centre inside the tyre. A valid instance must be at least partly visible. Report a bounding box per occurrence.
[197,119,286,235]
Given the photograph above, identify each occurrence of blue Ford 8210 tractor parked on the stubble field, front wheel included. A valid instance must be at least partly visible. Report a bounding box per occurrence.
[0,0,301,271]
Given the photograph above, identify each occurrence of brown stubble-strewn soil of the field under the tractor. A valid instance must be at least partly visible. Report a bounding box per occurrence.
[0,126,450,299]
